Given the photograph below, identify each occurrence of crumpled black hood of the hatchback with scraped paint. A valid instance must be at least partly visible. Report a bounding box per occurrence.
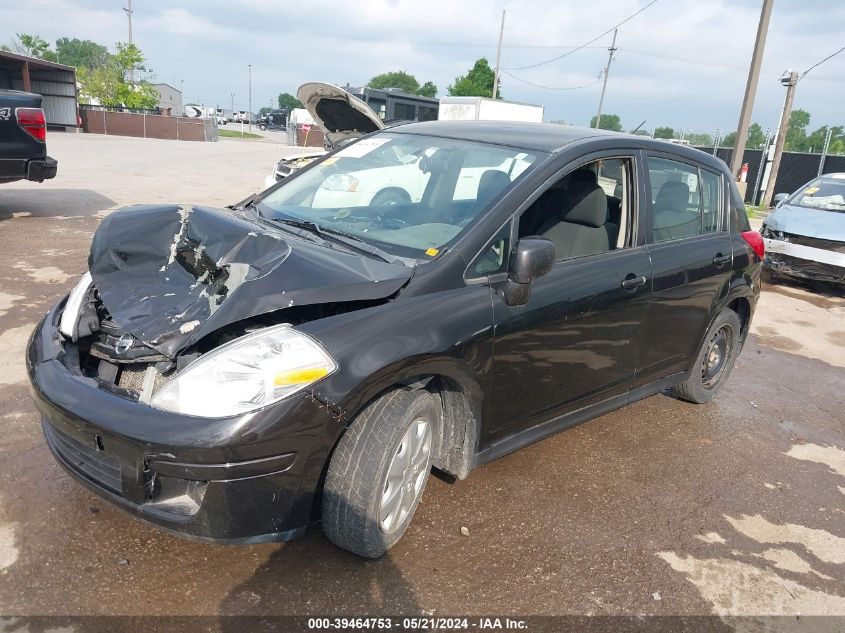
[88,205,412,358]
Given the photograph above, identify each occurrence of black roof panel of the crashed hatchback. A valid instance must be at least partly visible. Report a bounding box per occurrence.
[389,121,724,170]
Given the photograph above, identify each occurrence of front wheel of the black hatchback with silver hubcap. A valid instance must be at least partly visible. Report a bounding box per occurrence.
[322,389,440,558]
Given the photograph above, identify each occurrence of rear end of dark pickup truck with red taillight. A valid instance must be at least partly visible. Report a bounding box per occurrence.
[0,90,58,183]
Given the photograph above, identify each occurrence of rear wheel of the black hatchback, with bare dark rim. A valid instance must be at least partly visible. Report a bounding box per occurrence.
[672,308,742,404]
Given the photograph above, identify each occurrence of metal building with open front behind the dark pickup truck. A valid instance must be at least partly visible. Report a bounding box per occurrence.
[0,51,78,127]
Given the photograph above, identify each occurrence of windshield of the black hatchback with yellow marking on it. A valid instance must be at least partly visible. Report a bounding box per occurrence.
[258,132,538,260]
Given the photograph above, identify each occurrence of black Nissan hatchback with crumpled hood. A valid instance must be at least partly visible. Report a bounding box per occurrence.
[27,116,763,557]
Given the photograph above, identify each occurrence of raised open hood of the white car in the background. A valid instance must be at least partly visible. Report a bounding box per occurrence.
[296,81,384,147]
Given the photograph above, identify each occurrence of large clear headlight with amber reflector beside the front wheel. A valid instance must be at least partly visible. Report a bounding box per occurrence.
[150,323,337,418]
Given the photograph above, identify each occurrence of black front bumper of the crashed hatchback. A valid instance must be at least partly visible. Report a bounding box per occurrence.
[27,308,339,543]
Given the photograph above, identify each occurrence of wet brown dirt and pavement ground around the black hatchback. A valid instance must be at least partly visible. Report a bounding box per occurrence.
[0,134,845,630]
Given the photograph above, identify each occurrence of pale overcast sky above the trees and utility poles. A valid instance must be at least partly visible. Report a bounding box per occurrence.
[0,0,845,133]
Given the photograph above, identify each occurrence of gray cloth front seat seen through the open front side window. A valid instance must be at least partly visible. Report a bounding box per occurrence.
[540,180,610,260]
